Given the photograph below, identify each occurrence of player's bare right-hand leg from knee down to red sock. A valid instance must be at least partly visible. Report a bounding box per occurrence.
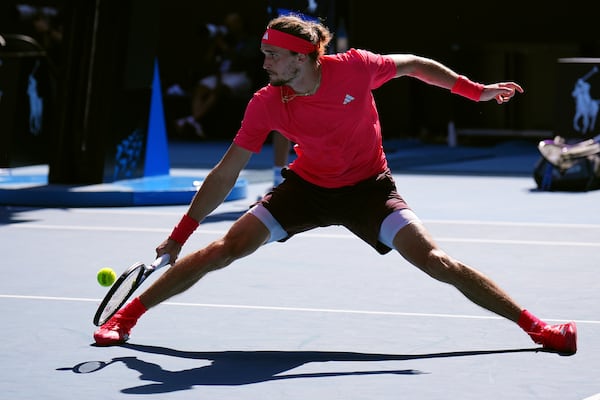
[394,223,522,322]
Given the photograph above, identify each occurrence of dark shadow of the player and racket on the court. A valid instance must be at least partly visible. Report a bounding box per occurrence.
[63,344,540,394]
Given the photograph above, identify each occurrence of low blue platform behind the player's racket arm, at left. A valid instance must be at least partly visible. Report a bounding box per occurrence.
[0,166,248,207]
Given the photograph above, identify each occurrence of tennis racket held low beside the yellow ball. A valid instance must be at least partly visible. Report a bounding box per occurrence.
[94,254,169,326]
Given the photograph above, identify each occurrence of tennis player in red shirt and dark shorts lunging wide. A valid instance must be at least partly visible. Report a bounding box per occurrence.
[94,16,577,353]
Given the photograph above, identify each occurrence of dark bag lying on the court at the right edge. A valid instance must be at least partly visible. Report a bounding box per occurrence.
[533,154,600,192]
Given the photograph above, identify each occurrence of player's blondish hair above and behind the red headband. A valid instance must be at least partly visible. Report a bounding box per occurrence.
[267,15,333,60]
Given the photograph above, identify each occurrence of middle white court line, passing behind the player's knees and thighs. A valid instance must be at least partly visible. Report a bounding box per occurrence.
[14,224,600,247]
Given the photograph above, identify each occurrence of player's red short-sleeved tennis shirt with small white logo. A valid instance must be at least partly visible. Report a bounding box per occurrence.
[234,49,396,188]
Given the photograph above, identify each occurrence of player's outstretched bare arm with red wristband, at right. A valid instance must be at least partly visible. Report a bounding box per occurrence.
[390,54,523,104]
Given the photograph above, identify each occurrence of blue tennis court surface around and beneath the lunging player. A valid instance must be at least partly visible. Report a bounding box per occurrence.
[0,139,600,400]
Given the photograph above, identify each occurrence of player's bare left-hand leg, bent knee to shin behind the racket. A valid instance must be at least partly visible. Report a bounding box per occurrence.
[139,214,269,308]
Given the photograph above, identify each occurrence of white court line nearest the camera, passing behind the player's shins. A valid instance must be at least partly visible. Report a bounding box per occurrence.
[0,294,600,324]
